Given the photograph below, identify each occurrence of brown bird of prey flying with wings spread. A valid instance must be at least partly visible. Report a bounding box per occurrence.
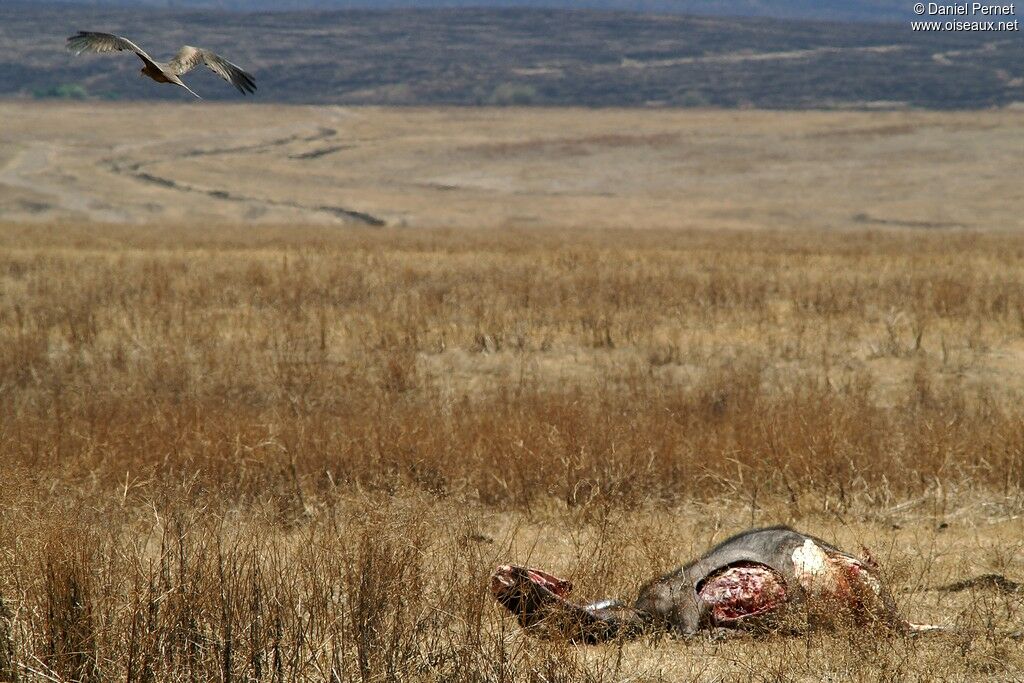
[68,31,256,99]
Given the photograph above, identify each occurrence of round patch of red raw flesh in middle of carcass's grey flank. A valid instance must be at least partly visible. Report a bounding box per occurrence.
[697,562,785,626]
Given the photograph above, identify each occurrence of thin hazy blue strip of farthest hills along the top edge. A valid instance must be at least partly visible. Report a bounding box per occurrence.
[32,0,911,22]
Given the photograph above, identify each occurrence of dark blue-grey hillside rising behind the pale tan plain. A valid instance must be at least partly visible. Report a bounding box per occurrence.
[0,2,1024,109]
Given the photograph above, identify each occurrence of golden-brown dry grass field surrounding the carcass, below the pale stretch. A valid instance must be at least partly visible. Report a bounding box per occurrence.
[0,223,1024,681]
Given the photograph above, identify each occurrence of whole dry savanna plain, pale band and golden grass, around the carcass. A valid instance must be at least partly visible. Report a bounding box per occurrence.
[0,101,1024,683]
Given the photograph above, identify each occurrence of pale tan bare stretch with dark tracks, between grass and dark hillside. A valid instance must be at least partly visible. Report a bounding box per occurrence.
[0,102,1024,230]
